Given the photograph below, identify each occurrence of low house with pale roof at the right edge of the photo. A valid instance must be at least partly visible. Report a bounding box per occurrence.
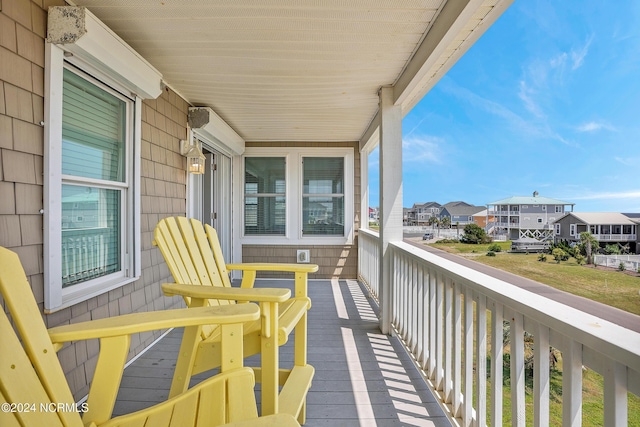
[553,212,639,252]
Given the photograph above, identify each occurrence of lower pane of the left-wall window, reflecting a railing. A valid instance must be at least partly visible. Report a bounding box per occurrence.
[62,185,122,288]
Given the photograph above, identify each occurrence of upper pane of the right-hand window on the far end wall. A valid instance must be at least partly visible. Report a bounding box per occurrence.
[302,157,344,194]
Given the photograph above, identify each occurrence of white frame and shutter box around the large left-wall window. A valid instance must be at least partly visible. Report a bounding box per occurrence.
[44,9,162,313]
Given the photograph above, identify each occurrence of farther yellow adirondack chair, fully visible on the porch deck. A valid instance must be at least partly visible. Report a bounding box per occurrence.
[153,217,318,424]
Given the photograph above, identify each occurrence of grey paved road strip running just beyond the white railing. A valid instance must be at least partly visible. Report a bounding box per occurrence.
[404,238,640,333]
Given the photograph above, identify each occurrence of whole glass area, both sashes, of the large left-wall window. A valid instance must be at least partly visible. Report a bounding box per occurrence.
[61,68,127,288]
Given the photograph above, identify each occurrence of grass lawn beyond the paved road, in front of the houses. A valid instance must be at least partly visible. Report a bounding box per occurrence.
[432,242,640,315]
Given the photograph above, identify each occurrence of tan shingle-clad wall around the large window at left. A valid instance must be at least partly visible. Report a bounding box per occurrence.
[0,0,187,399]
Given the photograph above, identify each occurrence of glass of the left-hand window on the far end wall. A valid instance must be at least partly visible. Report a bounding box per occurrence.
[244,157,286,236]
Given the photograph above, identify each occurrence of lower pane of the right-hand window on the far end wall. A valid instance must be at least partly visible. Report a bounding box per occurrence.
[302,196,344,236]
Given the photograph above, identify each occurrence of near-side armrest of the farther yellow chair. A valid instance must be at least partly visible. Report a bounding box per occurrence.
[162,283,291,304]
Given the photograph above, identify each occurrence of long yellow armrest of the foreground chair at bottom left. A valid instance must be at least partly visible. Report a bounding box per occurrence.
[48,304,260,343]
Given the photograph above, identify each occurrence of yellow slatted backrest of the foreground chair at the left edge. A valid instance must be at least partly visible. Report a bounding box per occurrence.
[0,247,82,426]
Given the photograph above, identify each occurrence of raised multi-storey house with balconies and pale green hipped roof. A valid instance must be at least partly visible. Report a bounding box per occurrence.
[487,191,575,241]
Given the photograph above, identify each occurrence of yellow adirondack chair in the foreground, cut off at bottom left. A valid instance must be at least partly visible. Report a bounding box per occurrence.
[0,247,299,427]
